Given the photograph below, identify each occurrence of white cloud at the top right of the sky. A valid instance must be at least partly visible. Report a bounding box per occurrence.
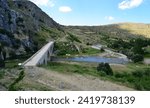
[118,0,143,10]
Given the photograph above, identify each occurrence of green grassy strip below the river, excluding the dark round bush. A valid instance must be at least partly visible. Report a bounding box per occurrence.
[43,62,150,90]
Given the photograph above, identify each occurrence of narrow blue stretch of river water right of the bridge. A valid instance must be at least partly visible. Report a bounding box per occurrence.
[52,56,128,64]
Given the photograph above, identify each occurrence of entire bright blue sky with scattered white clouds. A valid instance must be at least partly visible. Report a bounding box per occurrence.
[30,0,150,25]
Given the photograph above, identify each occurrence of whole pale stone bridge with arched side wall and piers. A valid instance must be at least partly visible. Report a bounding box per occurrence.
[22,41,54,67]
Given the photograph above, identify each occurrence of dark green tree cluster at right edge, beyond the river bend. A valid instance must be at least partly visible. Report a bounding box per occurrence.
[108,38,150,63]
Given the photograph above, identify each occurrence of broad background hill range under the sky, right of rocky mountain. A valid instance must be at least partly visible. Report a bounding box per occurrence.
[65,23,150,43]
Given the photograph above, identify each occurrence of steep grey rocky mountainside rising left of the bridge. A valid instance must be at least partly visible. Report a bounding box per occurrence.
[0,0,64,62]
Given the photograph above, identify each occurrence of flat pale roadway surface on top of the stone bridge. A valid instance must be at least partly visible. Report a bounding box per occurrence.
[24,42,54,66]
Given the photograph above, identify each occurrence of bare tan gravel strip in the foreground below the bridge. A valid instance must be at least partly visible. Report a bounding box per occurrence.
[26,67,133,91]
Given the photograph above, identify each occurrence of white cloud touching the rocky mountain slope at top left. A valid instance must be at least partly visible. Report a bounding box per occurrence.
[30,0,55,7]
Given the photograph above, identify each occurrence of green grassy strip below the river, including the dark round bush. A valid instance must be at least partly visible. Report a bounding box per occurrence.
[43,62,150,90]
